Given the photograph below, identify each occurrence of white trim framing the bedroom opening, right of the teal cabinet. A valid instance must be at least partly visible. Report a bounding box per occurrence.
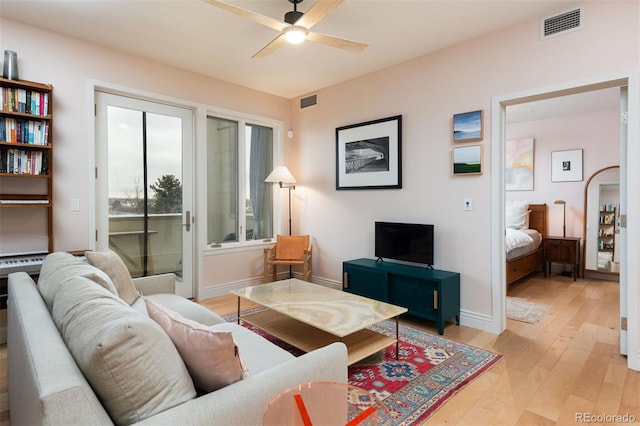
[491,70,640,371]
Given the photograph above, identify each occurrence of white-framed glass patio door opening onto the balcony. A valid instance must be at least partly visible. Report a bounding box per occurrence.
[95,91,194,297]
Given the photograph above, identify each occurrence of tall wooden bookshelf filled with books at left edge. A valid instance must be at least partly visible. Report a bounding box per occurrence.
[0,78,53,256]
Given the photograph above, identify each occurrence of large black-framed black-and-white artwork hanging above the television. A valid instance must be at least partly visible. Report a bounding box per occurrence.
[336,115,402,189]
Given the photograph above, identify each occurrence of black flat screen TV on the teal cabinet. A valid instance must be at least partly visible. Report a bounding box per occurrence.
[375,222,433,267]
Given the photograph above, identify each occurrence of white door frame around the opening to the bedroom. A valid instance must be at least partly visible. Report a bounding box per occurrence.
[491,73,640,370]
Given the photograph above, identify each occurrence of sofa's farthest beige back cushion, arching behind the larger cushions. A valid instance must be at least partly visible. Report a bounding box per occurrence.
[38,252,118,311]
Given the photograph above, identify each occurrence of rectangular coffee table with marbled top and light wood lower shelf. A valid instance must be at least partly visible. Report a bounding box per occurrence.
[231,278,407,365]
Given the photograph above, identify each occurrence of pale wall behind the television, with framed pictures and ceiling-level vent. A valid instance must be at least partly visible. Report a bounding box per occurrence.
[293,2,640,320]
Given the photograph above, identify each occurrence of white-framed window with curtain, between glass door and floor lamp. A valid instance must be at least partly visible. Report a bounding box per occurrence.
[207,116,276,244]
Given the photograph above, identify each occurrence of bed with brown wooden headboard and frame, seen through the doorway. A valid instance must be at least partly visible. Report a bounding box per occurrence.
[505,204,547,286]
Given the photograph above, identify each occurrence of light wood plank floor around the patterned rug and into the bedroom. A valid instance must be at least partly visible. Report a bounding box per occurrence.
[0,276,640,426]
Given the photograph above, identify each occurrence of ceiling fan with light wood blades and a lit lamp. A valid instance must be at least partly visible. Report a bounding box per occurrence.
[204,0,367,58]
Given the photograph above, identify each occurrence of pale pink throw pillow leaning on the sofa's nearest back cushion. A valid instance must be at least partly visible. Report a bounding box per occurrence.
[145,298,246,392]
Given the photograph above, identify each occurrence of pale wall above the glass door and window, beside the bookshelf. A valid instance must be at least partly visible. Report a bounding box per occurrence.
[0,18,290,255]
